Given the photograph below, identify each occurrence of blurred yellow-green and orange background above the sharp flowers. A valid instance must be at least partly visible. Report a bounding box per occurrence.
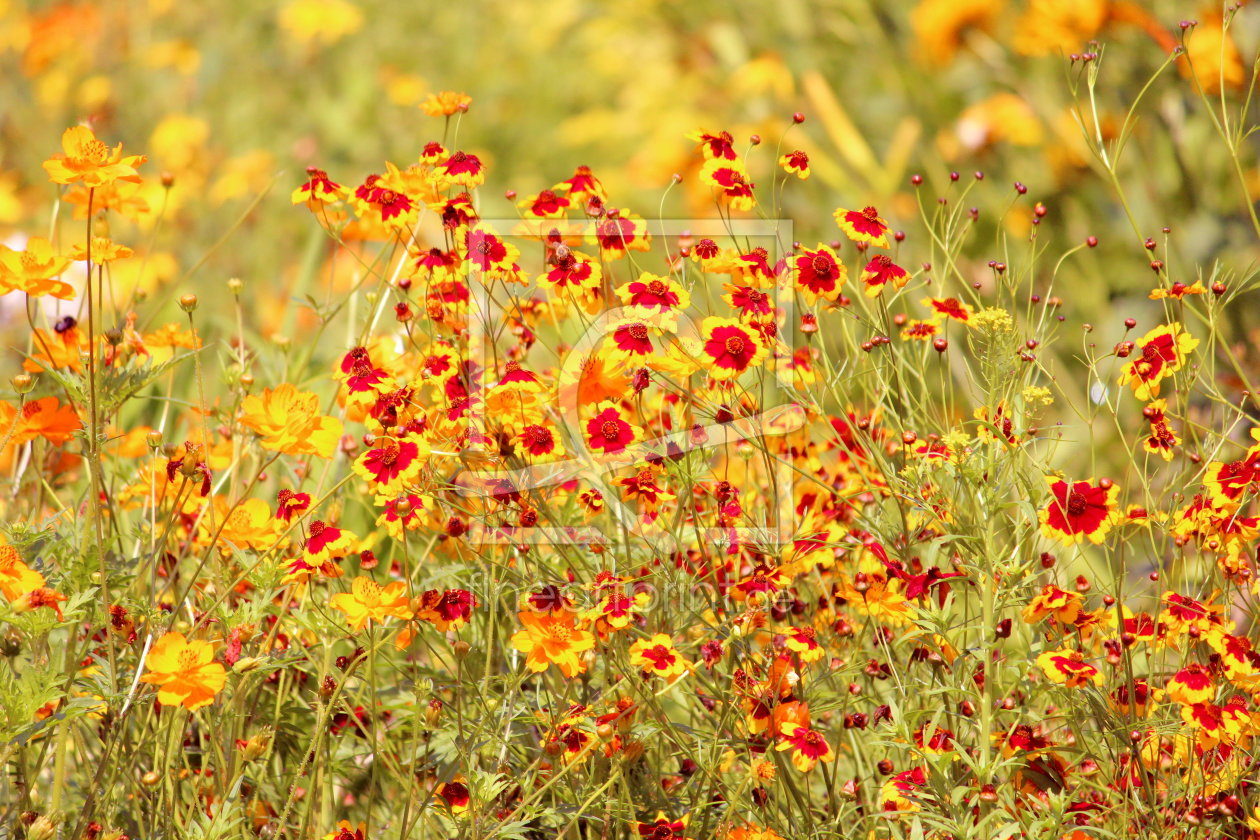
[0,0,1260,357]
